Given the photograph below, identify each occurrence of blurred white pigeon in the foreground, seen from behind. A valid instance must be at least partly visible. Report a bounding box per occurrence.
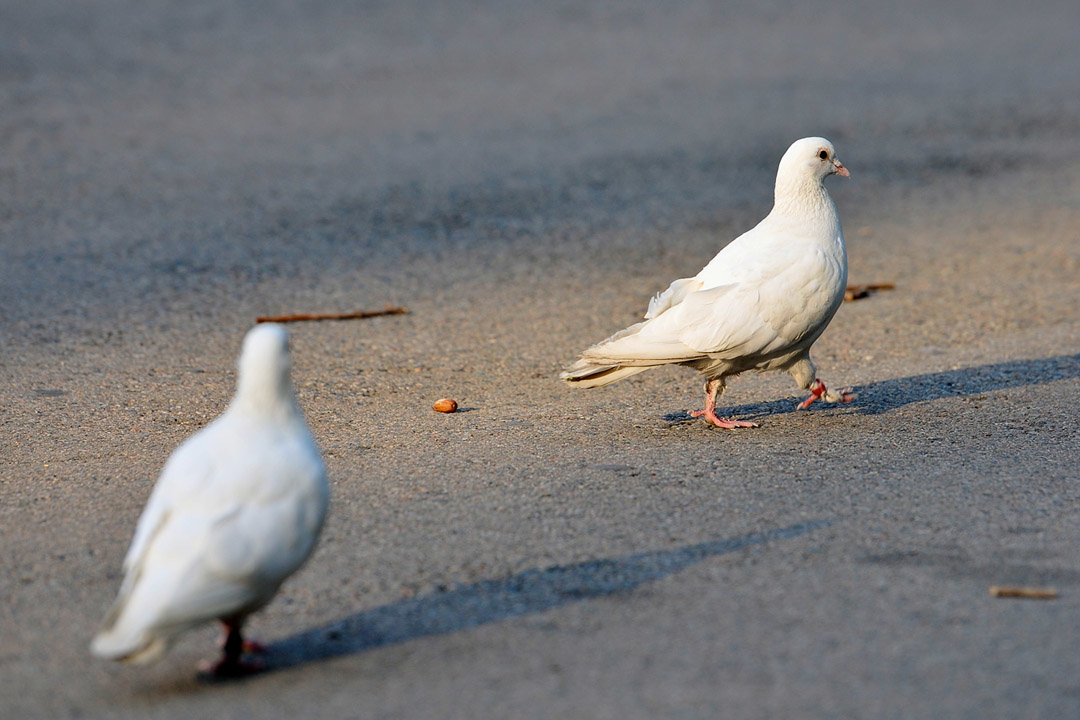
[91,324,329,676]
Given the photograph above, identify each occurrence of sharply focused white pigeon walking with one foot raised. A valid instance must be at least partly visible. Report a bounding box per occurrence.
[559,137,854,427]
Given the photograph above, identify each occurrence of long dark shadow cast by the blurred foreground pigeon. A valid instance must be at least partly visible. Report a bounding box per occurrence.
[257,520,832,673]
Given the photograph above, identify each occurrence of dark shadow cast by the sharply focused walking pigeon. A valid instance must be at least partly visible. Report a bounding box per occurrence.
[663,354,1080,424]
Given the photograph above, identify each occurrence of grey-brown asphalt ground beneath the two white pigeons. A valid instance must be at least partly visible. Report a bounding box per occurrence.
[0,0,1080,719]
